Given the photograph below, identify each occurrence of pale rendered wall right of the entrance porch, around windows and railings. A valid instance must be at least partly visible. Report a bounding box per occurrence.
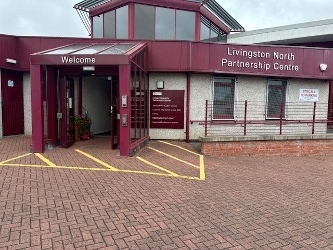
[149,74,329,140]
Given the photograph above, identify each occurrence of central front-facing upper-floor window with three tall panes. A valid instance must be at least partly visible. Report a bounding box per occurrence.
[135,4,195,40]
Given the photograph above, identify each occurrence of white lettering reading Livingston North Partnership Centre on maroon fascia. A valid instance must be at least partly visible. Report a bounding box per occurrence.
[221,47,300,71]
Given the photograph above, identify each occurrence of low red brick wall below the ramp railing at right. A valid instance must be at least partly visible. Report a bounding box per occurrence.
[201,139,333,156]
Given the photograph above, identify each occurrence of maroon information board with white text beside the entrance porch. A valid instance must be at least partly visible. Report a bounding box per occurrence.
[150,90,185,129]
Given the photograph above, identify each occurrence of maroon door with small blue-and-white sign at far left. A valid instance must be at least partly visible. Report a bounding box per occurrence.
[1,70,24,136]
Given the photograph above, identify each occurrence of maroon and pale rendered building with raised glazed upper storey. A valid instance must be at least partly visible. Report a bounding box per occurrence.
[0,0,333,156]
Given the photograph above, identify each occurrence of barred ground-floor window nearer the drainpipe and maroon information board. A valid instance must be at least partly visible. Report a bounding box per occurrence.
[212,78,235,120]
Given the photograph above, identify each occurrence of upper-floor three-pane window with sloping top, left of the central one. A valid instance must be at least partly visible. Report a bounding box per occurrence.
[93,5,128,39]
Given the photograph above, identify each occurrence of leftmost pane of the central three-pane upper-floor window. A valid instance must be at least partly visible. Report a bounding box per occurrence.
[135,4,155,40]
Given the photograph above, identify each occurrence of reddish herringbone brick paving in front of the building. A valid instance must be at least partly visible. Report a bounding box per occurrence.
[0,137,333,250]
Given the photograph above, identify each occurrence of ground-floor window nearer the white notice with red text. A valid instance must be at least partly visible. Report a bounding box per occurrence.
[266,79,287,119]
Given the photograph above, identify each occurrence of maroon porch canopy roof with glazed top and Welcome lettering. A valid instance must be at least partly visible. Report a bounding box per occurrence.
[31,43,146,66]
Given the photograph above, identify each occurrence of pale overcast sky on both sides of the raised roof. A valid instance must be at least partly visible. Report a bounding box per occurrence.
[0,0,333,37]
